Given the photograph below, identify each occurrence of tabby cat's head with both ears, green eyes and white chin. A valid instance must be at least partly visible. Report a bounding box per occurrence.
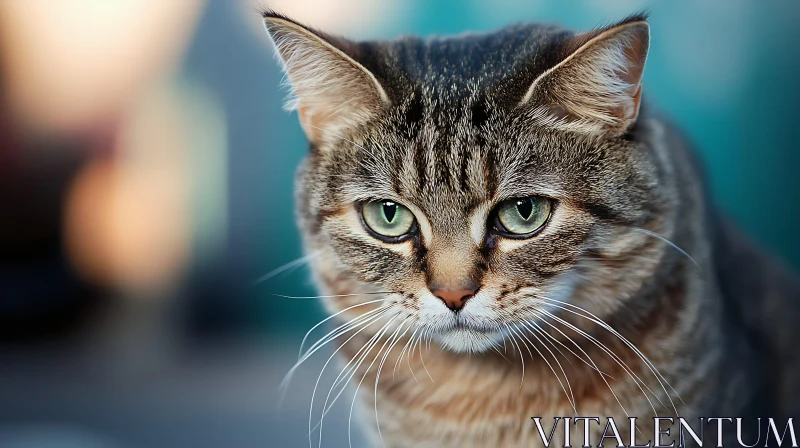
[265,12,670,351]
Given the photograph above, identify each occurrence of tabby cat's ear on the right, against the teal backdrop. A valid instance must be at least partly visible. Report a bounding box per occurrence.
[520,16,650,136]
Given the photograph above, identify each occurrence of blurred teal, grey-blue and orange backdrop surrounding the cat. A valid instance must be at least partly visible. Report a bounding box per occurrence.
[0,0,800,447]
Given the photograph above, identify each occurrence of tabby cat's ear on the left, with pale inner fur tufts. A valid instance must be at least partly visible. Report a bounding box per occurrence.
[263,11,389,143]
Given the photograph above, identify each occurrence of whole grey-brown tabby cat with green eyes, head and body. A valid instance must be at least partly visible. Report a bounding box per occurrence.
[263,11,800,447]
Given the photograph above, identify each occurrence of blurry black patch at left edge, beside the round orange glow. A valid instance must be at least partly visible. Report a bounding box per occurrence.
[0,120,107,342]
